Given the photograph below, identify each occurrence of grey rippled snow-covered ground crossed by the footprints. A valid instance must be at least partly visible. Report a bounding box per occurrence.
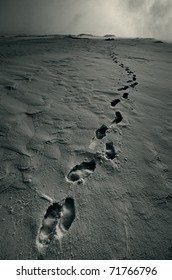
[0,35,172,259]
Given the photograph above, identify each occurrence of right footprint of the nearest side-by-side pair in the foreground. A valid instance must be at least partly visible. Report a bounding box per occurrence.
[55,197,75,240]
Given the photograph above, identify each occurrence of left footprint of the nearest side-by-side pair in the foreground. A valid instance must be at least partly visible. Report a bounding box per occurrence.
[38,203,61,246]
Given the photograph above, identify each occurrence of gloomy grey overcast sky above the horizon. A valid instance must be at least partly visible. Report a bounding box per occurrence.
[0,0,172,40]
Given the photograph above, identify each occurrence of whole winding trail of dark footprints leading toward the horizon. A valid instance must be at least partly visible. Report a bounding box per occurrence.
[36,48,138,253]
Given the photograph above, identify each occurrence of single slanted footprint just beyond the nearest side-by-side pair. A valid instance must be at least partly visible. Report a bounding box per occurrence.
[67,160,96,182]
